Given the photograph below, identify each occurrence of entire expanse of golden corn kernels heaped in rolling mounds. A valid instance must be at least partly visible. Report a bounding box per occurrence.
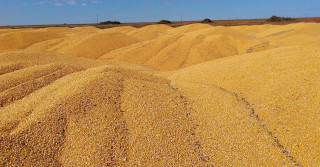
[0,23,320,166]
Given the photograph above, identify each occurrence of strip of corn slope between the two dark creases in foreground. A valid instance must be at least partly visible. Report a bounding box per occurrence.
[172,80,292,166]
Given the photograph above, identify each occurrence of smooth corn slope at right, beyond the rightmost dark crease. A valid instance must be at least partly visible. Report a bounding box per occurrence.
[166,47,320,166]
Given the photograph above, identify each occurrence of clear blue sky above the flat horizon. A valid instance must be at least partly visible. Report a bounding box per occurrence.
[0,0,320,25]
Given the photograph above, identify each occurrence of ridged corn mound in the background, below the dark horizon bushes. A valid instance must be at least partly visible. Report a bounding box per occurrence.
[100,24,264,70]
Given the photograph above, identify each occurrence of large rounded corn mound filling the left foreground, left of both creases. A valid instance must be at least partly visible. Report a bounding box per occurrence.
[0,65,206,166]
